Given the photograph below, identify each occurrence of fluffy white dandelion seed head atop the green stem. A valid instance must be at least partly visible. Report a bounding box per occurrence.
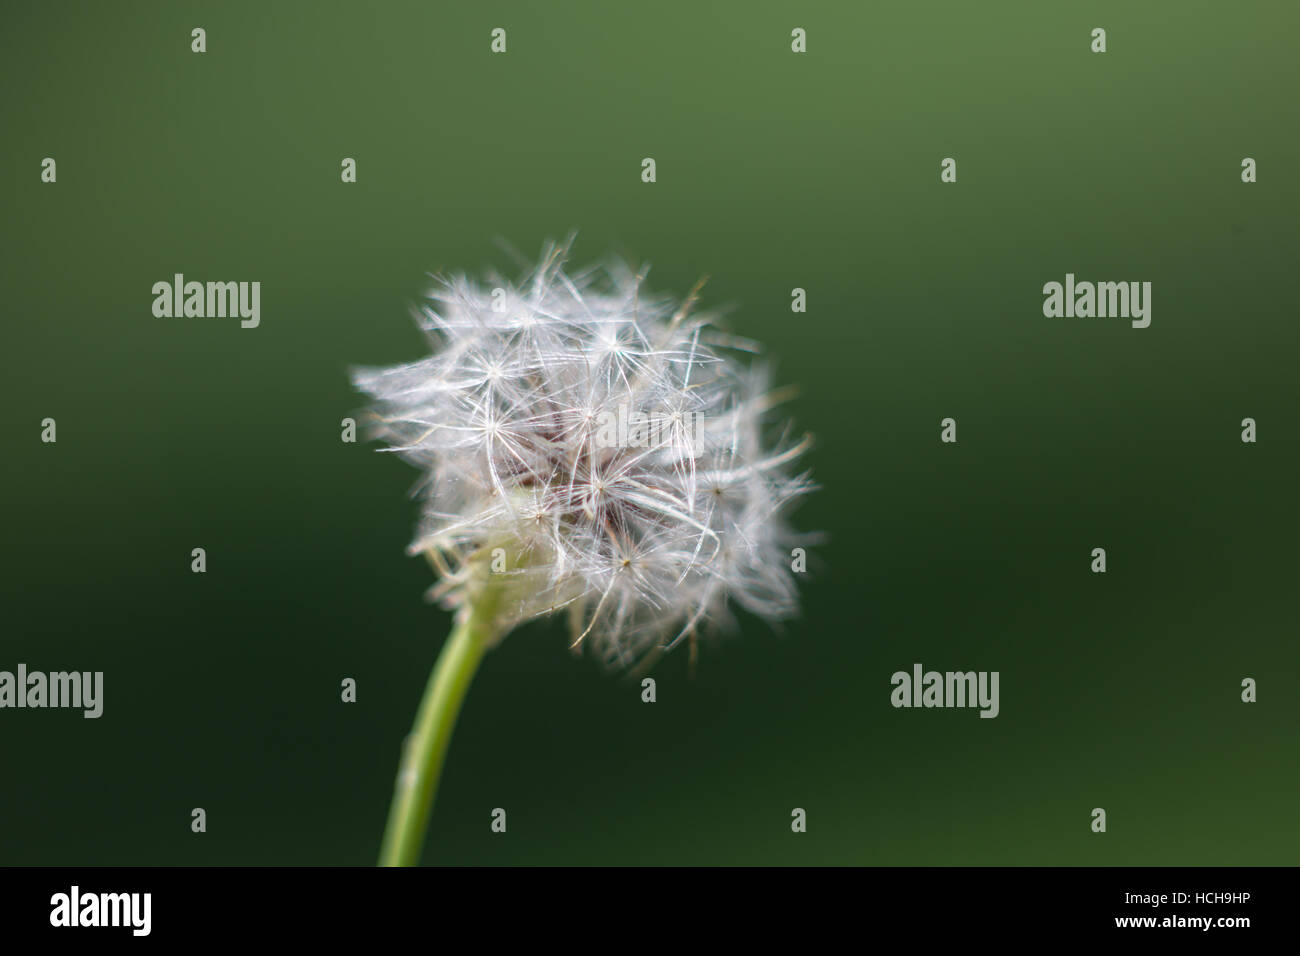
[354,245,813,669]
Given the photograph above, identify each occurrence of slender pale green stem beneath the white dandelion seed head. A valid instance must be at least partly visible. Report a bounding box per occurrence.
[380,600,495,866]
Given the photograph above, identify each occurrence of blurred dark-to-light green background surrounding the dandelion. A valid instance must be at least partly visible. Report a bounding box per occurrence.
[0,0,1300,864]
